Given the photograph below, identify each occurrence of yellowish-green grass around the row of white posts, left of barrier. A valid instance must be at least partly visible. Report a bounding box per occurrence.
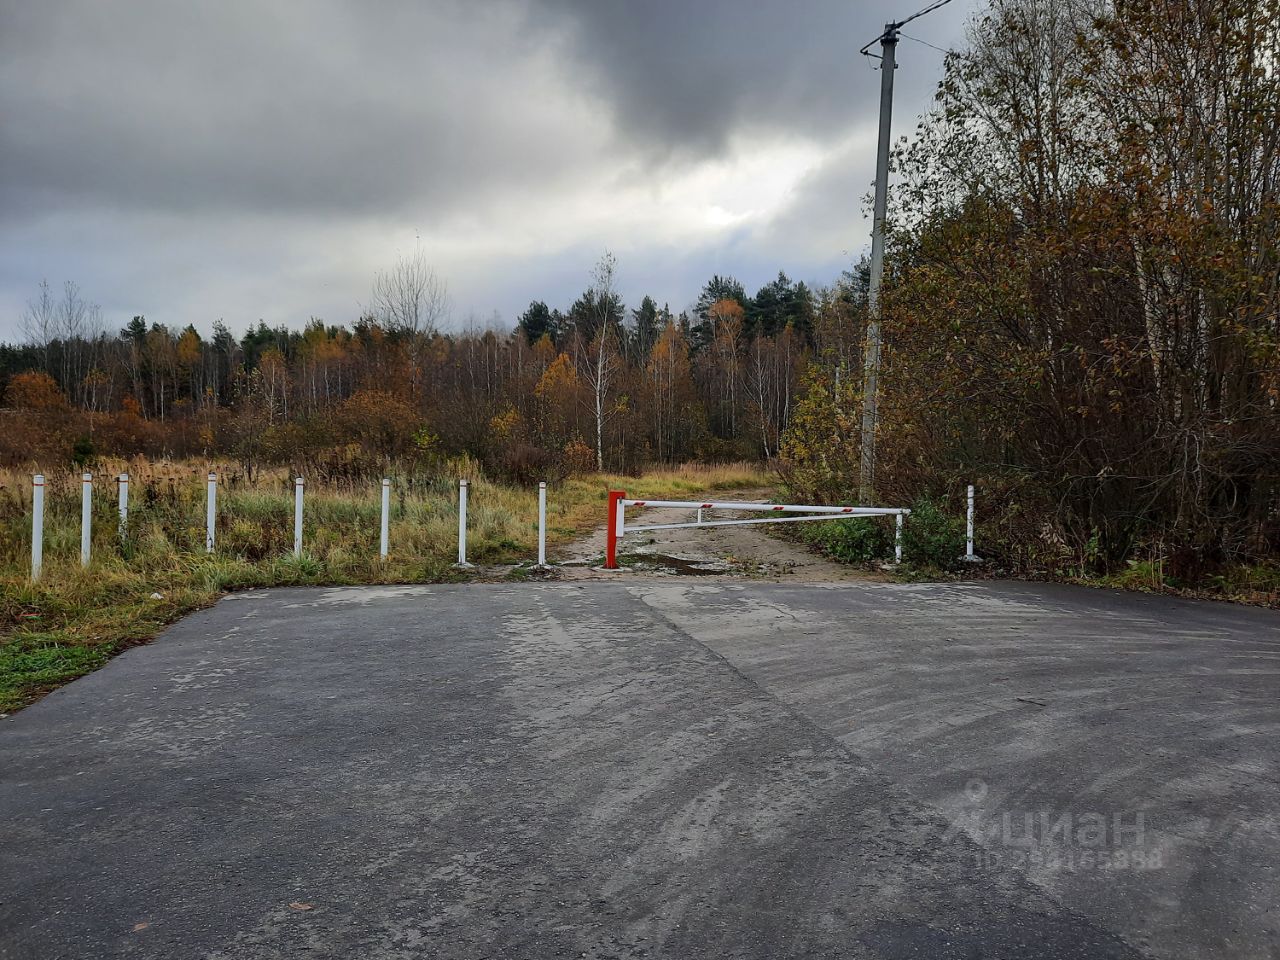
[0,461,771,713]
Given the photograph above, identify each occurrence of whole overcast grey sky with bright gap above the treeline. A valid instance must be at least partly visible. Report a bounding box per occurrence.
[0,0,977,339]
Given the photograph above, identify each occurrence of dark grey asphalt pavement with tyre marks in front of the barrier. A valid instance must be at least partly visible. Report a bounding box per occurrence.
[0,573,1280,960]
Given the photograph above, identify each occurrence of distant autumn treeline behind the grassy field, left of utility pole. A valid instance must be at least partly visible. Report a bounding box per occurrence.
[0,255,831,480]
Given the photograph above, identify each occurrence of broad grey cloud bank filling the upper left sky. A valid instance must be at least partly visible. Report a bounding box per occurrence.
[0,0,604,214]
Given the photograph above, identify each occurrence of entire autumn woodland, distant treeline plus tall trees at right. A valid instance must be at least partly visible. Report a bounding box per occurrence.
[0,0,1280,581]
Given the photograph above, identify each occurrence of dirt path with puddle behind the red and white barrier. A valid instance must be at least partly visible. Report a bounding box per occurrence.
[557,489,884,582]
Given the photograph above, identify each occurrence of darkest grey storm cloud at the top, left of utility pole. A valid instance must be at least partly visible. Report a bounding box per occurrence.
[535,0,970,154]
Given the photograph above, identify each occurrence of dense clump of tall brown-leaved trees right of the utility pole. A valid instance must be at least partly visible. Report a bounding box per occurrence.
[783,0,1280,576]
